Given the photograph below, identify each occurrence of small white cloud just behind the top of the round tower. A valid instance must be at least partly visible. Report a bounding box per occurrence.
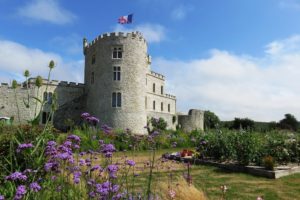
[114,24,166,43]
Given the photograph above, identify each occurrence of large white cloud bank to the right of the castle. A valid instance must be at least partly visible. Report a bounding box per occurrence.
[153,36,300,121]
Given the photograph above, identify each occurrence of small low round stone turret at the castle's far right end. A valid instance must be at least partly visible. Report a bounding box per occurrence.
[178,109,204,132]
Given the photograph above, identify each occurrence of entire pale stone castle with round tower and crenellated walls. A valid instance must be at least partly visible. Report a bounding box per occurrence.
[0,32,204,134]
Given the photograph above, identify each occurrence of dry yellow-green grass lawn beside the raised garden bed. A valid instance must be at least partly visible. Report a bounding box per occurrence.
[109,149,300,200]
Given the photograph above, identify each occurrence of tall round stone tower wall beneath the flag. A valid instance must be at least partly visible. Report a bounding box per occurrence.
[84,33,148,134]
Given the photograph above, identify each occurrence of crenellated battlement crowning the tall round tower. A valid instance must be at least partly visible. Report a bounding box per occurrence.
[83,31,146,50]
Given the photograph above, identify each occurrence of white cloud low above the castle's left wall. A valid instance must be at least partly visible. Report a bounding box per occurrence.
[0,40,84,82]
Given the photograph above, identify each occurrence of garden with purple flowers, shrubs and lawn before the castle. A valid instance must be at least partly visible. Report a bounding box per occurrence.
[0,62,300,200]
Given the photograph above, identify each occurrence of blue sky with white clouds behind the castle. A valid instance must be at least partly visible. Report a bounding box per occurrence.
[0,0,300,121]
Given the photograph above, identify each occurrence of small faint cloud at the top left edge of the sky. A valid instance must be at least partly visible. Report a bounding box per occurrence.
[18,0,76,25]
